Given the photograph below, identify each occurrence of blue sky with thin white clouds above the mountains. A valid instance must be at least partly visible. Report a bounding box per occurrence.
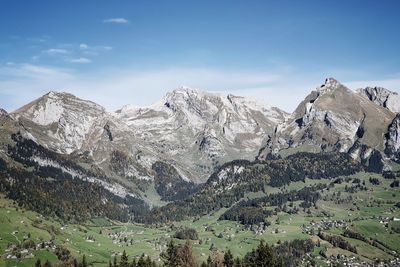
[0,0,400,112]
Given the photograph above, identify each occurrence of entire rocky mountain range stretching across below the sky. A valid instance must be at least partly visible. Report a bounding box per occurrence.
[0,78,400,209]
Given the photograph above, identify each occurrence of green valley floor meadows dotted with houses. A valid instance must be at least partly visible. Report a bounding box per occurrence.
[0,173,400,266]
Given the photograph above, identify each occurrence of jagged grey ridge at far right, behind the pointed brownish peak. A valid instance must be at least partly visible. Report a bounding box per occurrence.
[357,87,400,113]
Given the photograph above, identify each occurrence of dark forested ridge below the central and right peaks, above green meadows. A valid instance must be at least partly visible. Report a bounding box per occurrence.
[137,152,362,223]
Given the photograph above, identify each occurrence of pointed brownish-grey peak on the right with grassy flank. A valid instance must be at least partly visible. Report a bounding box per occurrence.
[259,78,395,159]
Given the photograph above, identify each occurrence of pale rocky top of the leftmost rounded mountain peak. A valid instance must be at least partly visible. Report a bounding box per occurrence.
[11,91,112,154]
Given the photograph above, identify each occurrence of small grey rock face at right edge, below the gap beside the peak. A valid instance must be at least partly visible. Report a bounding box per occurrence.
[385,114,400,162]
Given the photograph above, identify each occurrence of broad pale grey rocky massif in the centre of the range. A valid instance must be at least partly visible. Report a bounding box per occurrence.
[115,87,287,181]
